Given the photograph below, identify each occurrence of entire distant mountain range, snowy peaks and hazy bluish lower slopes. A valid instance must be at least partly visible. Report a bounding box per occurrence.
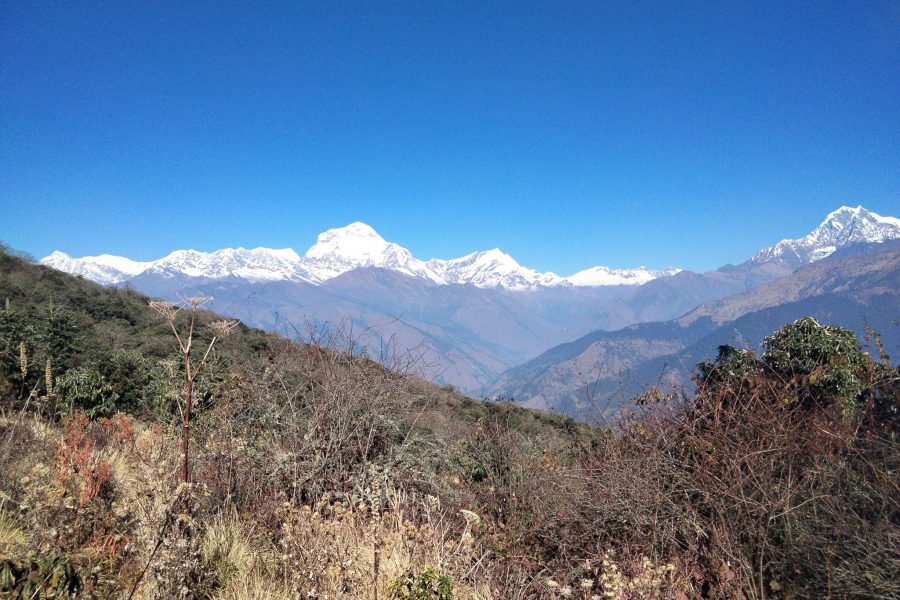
[41,206,900,398]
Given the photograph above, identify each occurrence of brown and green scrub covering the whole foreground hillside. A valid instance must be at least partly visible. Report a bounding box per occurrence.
[0,246,900,599]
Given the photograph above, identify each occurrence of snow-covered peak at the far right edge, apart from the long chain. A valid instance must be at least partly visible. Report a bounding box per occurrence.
[749,206,900,266]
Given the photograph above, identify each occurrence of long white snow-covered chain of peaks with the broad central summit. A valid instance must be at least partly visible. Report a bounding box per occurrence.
[40,222,680,291]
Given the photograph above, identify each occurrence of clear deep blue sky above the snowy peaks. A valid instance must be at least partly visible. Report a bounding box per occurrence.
[0,0,900,274]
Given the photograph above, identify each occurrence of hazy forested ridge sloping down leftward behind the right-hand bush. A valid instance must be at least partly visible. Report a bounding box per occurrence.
[482,240,900,413]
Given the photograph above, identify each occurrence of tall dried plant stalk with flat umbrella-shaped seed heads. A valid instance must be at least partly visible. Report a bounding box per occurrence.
[150,296,239,483]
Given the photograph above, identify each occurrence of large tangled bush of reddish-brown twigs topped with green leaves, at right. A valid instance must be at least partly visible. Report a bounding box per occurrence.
[676,318,900,597]
